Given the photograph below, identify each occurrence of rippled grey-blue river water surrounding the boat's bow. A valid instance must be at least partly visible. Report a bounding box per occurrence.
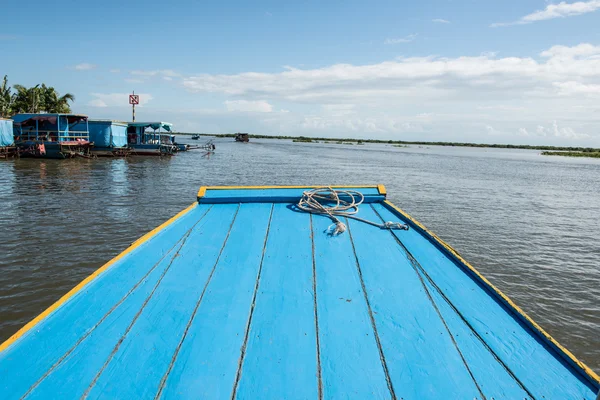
[0,138,600,371]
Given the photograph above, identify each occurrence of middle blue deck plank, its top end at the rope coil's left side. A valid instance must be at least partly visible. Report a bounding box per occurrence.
[237,204,318,399]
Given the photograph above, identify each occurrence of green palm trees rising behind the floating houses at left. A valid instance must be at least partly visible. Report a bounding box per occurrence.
[0,75,75,118]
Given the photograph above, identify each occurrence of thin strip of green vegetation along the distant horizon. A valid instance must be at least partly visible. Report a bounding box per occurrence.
[177,132,600,153]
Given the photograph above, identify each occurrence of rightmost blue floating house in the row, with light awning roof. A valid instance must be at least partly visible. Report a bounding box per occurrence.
[127,122,177,156]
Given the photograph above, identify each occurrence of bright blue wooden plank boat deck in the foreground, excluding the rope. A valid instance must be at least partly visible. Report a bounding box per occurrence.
[0,187,600,400]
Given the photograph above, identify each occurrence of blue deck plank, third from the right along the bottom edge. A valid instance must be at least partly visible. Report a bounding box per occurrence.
[349,206,482,399]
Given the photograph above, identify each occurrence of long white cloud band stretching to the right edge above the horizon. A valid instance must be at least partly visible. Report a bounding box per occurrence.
[183,44,600,104]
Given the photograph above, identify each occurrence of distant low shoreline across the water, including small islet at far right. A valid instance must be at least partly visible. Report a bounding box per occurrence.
[173,132,600,157]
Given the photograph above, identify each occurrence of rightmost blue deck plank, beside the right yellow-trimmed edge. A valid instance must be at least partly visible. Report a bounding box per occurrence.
[373,204,596,400]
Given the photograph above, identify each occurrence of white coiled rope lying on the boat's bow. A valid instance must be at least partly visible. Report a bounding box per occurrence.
[298,187,408,236]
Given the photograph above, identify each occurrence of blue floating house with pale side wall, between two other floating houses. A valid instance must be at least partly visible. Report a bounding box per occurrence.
[75,119,131,157]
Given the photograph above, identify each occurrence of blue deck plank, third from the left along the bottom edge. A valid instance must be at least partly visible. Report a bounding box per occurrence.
[85,204,239,399]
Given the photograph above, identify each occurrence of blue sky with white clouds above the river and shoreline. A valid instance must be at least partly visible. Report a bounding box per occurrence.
[0,0,600,146]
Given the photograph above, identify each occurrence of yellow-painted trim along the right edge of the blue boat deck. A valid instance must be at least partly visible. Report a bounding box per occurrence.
[384,200,600,384]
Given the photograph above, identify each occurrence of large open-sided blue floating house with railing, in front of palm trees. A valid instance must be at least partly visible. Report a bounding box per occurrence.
[12,114,92,158]
